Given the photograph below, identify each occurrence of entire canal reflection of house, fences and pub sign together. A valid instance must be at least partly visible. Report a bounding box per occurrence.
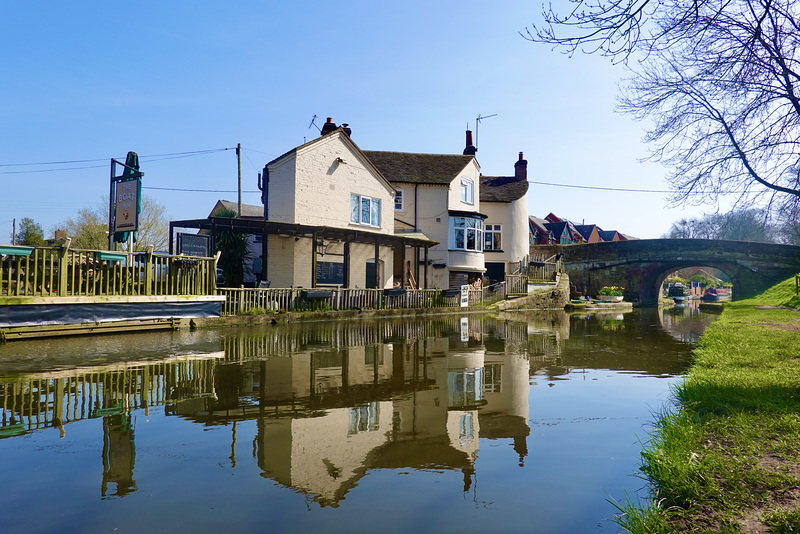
[0,318,529,506]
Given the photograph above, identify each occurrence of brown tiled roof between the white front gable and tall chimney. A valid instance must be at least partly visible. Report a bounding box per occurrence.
[363,150,474,185]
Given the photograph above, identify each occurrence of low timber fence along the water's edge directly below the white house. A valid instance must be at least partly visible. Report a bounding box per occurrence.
[217,282,506,315]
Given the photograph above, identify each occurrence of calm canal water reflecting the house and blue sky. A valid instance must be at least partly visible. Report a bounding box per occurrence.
[0,308,712,533]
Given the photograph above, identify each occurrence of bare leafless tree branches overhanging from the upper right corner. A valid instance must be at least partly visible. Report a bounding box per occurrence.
[525,0,800,213]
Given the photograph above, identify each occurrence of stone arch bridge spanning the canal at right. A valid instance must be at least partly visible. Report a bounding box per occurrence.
[552,239,800,305]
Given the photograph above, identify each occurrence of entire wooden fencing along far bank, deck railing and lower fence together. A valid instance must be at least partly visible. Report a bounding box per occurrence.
[0,245,527,315]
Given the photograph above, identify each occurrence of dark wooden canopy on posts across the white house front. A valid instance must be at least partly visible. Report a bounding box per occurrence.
[169,217,439,287]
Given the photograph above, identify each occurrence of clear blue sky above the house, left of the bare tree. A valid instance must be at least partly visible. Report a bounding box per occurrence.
[0,0,720,243]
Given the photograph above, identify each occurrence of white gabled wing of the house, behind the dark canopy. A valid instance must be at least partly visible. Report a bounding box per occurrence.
[263,121,394,288]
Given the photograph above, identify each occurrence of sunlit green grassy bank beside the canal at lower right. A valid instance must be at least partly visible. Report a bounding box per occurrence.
[618,278,800,534]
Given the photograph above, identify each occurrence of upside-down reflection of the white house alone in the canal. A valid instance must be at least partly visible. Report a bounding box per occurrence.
[254,332,529,506]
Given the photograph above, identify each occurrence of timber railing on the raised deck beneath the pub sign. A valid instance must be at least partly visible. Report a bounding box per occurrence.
[0,245,216,304]
